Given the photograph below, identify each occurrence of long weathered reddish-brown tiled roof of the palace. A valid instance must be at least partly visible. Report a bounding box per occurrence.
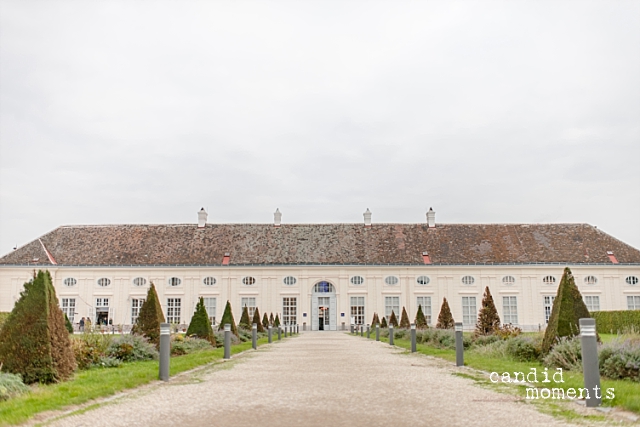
[0,224,640,265]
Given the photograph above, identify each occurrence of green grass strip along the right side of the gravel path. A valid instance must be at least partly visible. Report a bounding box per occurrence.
[372,335,640,413]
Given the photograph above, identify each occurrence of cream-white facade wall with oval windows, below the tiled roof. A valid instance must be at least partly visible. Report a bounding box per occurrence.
[0,264,640,330]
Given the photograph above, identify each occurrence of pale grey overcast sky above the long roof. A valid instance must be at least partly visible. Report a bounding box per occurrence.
[0,0,640,254]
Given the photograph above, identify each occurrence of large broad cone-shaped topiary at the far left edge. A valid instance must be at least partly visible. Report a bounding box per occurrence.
[0,271,76,384]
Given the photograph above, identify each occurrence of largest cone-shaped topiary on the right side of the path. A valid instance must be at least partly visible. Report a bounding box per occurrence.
[542,267,591,354]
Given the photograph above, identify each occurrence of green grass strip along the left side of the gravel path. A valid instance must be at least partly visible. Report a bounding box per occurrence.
[0,338,268,426]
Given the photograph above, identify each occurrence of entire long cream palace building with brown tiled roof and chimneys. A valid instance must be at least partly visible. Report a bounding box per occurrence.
[0,209,640,330]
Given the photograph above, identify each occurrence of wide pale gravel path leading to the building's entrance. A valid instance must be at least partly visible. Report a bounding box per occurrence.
[47,332,566,427]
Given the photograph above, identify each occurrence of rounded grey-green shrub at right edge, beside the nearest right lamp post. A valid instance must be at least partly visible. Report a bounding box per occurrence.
[598,338,640,382]
